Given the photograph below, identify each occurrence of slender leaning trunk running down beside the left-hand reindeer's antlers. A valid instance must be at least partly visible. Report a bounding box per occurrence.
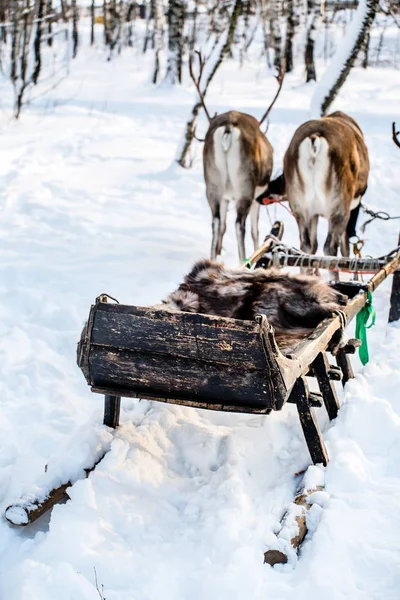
[177,0,242,168]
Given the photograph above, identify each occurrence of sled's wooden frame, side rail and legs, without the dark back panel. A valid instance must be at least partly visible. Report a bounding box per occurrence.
[78,222,400,465]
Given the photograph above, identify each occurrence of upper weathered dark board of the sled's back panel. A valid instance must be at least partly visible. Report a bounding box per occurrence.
[91,303,265,369]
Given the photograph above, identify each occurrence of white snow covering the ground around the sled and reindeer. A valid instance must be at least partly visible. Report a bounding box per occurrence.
[0,25,400,600]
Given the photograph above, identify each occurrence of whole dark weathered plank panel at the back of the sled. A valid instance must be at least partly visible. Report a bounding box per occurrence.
[78,302,281,413]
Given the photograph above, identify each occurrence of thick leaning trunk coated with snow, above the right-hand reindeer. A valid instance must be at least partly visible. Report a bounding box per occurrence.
[312,0,379,115]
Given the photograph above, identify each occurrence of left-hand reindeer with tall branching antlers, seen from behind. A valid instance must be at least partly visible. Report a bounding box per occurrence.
[189,52,283,261]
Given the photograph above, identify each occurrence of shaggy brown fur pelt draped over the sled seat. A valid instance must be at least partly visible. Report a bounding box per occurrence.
[163,260,347,353]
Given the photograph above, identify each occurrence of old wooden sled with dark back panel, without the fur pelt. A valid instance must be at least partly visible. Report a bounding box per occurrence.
[6,222,400,540]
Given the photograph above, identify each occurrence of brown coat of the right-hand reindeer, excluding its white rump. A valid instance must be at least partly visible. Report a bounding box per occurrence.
[284,111,369,256]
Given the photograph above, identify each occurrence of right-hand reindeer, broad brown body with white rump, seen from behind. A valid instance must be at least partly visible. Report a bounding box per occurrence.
[262,111,369,256]
